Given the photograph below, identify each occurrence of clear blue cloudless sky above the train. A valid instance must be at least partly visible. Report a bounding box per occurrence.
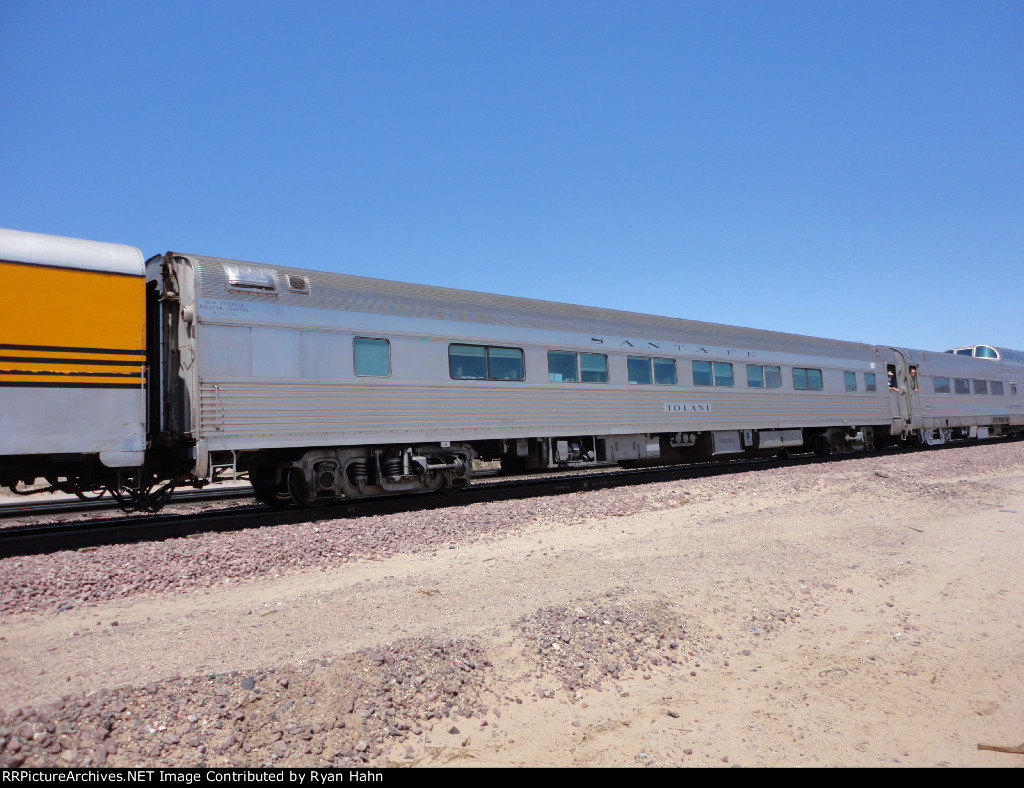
[0,0,1024,350]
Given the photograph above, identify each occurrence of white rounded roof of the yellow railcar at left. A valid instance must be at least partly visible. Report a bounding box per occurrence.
[0,227,145,276]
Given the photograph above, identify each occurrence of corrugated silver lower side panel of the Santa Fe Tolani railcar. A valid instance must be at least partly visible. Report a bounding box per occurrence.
[195,380,890,448]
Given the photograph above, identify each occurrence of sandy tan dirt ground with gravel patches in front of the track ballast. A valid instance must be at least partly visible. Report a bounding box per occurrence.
[0,443,1024,768]
